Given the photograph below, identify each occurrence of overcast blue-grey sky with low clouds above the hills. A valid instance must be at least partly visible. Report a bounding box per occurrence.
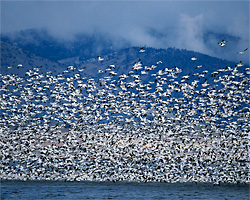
[1,0,249,62]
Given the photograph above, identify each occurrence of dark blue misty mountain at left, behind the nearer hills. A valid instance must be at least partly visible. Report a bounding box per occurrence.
[1,29,128,61]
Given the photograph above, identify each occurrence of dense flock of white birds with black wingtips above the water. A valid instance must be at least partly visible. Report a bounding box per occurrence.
[0,45,250,184]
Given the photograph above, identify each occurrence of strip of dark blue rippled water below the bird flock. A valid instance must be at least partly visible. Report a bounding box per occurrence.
[1,181,249,200]
